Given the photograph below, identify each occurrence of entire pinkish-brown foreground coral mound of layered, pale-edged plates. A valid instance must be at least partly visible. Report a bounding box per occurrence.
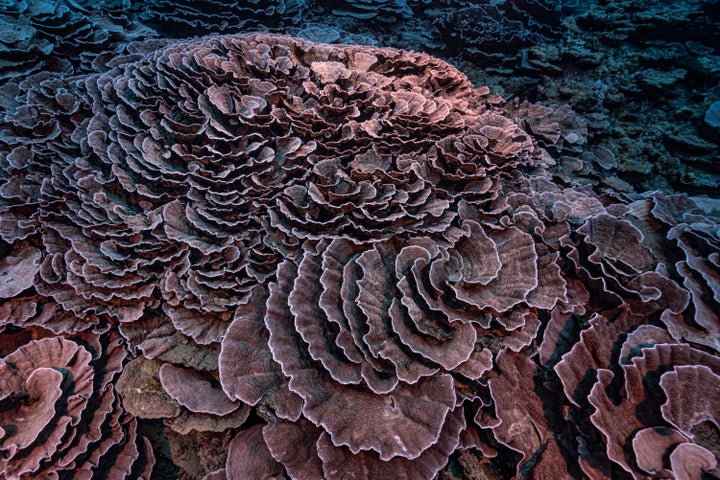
[0,34,720,479]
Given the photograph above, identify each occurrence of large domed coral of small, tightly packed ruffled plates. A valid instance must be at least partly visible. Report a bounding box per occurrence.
[1,34,544,344]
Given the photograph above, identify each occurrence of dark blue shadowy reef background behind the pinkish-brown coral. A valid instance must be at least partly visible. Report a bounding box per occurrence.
[0,0,720,198]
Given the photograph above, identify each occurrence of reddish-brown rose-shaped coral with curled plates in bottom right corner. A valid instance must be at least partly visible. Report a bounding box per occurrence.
[555,311,720,479]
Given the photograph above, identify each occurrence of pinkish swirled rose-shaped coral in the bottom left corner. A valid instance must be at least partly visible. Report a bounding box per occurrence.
[0,316,154,479]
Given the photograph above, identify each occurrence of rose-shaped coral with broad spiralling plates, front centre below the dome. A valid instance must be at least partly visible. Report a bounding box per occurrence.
[219,199,565,478]
